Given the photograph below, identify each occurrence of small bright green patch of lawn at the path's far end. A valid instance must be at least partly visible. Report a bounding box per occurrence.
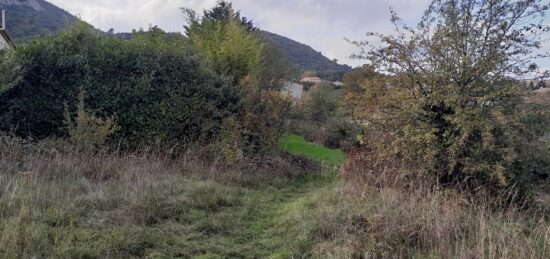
[279,135,346,166]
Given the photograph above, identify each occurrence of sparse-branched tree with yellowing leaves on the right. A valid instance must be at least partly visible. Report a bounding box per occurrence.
[347,0,548,189]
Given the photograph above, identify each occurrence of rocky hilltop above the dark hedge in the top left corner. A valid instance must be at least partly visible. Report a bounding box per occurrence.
[0,0,78,40]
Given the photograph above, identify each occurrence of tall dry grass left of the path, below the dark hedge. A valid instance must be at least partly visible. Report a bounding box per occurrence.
[0,135,320,258]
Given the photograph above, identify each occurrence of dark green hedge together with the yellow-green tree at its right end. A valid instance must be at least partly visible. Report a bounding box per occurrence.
[0,4,290,155]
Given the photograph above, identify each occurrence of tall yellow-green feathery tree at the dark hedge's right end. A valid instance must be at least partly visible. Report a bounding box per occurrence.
[185,2,290,154]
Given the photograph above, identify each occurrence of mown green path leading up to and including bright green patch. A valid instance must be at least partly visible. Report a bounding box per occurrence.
[188,135,345,258]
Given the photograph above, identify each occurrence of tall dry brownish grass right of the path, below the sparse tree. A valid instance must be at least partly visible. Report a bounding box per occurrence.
[313,150,550,258]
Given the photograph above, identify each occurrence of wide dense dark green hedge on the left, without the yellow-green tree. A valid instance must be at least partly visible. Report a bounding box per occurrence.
[0,25,239,146]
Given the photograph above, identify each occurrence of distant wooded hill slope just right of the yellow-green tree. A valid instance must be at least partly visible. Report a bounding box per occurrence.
[262,31,351,81]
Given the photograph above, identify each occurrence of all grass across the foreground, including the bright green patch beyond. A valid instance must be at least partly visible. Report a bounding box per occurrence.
[0,136,550,258]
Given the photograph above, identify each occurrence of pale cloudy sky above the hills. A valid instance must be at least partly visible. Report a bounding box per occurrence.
[48,0,550,69]
